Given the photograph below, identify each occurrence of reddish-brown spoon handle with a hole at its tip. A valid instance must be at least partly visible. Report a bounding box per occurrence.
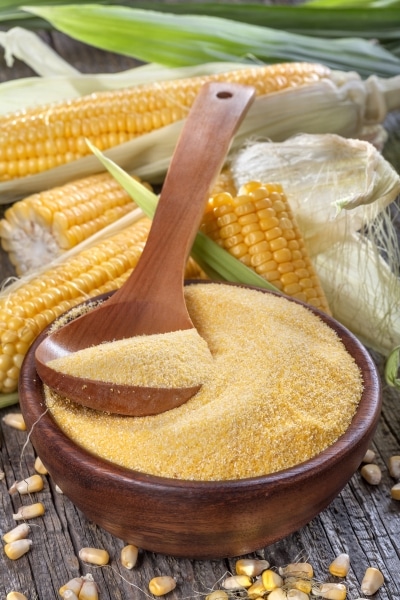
[117,82,255,301]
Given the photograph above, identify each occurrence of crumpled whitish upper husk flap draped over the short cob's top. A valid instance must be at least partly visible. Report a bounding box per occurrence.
[230,134,400,256]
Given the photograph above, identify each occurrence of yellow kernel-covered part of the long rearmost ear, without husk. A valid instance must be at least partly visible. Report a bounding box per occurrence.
[0,63,331,181]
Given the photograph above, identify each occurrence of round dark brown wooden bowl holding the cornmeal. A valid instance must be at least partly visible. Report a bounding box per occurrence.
[19,290,381,559]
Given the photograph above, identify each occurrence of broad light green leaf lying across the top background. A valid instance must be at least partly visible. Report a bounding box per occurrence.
[23,4,400,77]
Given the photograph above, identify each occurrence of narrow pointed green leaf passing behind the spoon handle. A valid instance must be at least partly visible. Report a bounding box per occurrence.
[87,141,278,292]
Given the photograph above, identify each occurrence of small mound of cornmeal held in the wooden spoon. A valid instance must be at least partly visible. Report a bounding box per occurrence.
[48,328,213,388]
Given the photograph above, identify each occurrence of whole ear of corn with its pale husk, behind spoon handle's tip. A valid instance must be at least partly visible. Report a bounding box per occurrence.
[0,58,400,203]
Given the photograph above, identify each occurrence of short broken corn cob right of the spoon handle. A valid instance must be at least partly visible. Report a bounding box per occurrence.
[201,182,330,314]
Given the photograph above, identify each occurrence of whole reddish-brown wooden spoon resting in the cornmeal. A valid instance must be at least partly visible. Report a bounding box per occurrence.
[35,82,255,416]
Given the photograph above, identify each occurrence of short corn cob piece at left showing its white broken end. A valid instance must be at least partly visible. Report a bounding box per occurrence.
[0,173,151,275]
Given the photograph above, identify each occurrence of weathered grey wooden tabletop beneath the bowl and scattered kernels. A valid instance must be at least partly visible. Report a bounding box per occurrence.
[0,28,400,600]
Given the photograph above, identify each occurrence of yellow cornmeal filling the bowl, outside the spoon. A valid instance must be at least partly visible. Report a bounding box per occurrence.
[47,284,363,480]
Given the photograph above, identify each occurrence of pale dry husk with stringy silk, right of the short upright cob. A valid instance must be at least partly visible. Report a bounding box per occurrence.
[231,135,400,356]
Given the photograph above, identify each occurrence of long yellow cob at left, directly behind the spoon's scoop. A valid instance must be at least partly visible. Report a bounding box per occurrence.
[0,217,200,393]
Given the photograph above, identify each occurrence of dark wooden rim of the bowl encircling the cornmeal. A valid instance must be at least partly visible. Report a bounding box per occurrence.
[19,280,382,494]
